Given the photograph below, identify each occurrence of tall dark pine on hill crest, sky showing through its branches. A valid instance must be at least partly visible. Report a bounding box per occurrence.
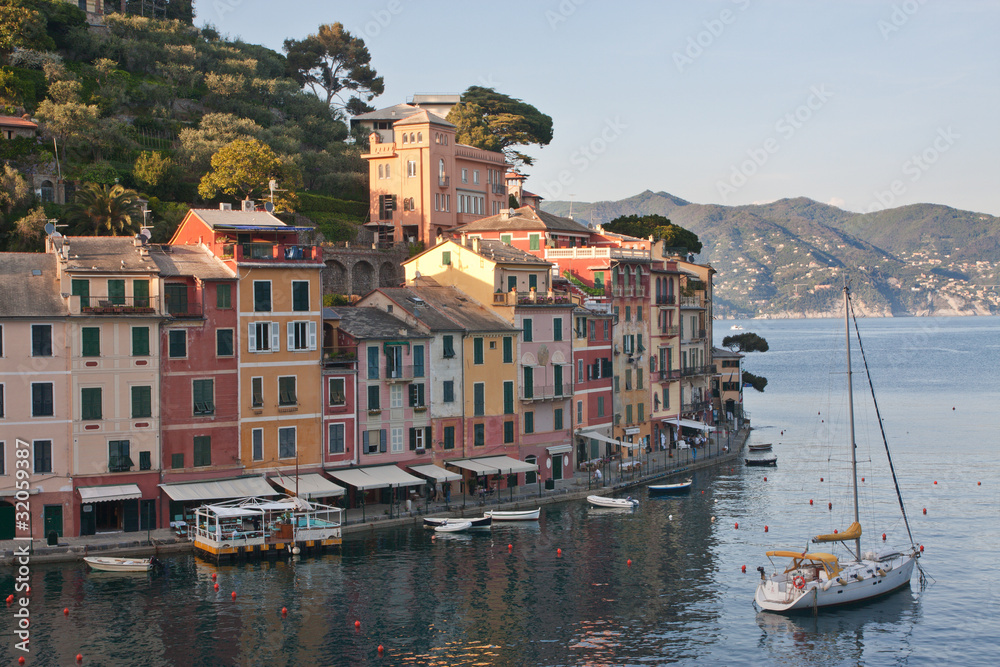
[285,23,385,116]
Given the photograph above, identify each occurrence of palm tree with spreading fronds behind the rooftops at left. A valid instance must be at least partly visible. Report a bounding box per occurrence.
[66,183,142,236]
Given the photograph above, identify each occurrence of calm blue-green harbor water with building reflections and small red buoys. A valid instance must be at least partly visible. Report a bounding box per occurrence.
[0,318,1000,665]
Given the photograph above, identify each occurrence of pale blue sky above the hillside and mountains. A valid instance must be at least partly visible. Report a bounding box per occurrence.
[195,0,1000,215]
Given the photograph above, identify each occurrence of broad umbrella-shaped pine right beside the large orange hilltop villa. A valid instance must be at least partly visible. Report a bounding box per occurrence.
[448,86,552,167]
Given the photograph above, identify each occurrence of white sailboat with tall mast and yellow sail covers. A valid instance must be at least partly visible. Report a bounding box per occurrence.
[747,285,922,612]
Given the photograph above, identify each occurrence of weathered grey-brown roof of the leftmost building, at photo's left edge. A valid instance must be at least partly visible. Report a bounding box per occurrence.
[0,252,69,317]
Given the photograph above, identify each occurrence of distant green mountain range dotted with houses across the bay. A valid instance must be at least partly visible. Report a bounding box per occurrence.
[542,190,1000,317]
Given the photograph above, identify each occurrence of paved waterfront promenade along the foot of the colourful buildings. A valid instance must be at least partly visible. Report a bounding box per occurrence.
[0,425,750,565]
